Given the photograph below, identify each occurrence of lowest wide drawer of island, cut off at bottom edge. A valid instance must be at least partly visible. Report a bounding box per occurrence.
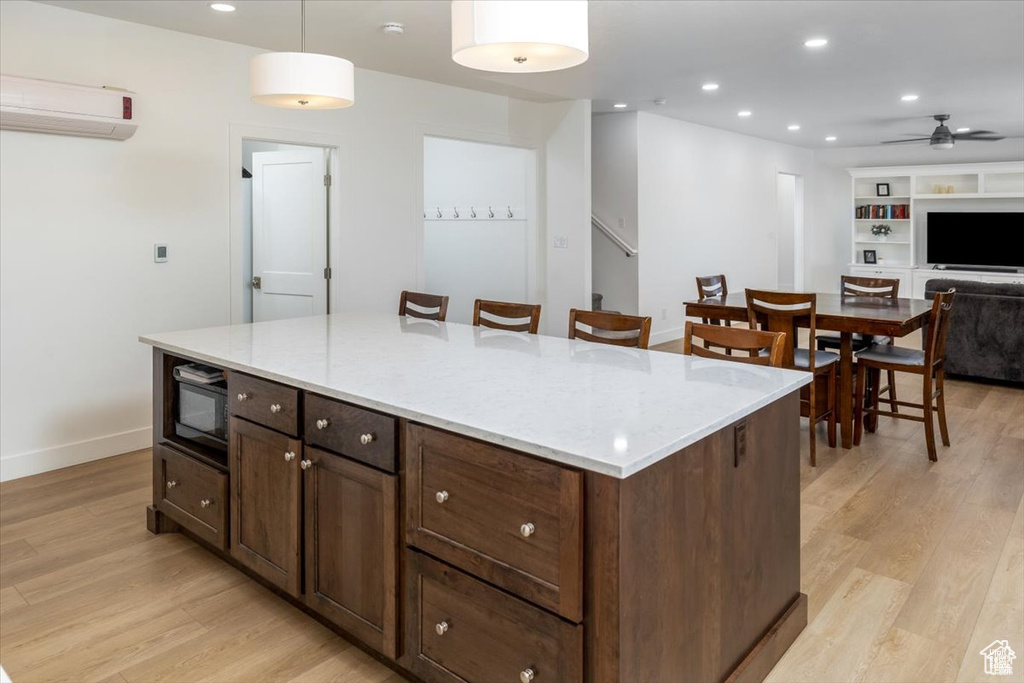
[402,551,583,683]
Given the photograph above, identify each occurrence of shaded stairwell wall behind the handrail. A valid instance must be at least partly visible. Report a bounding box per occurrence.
[591,112,642,314]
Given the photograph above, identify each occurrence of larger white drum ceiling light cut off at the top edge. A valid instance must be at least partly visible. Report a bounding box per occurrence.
[452,0,590,74]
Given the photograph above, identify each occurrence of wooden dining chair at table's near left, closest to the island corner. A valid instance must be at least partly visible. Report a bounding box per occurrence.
[745,289,839,467]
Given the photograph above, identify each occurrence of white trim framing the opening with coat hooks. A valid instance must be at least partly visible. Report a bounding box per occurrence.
[413,124,547,309]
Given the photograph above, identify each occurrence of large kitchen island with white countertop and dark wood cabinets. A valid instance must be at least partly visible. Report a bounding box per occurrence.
[140,314,810,683]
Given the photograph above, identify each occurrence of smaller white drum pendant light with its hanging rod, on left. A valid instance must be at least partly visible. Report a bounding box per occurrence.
[249,0,355,110]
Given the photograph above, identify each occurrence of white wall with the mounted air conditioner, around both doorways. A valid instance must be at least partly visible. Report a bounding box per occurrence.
[0,0,590,478]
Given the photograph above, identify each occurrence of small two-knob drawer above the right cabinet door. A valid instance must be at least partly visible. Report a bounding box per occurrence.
[303,393,397,472]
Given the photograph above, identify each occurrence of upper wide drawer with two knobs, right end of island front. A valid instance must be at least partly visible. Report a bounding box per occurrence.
[406,425,583,622]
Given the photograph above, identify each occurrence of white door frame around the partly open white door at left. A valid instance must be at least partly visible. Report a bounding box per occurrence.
[227,123,348,325]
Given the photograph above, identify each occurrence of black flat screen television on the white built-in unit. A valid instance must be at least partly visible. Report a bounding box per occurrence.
[925,211,1024,268]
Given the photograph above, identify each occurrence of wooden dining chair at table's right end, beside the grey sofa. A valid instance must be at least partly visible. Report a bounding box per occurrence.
[853,289,956,462]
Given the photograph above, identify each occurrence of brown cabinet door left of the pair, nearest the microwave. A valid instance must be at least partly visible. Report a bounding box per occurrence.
[229,417,302,597]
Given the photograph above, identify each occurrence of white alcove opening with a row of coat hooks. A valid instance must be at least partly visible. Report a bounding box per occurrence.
[423,135,538,324]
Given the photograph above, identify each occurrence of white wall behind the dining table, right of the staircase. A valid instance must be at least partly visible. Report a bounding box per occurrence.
[638,112,823,344]
